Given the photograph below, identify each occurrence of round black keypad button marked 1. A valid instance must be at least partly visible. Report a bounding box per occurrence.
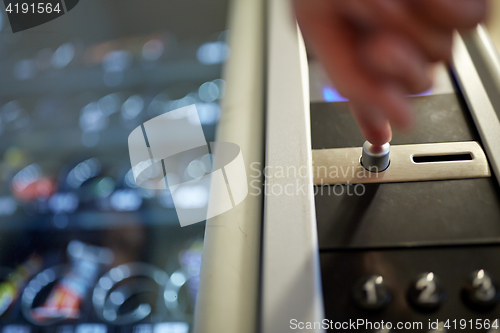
[353,275,392,311]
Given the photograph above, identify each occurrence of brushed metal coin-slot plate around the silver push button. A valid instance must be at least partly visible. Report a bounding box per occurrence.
[312,141,491,185]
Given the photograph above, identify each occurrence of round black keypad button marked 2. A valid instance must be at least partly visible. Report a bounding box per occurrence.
[408,272,446,312]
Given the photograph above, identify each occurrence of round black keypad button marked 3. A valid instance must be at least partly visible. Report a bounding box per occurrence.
[462,269,500,311]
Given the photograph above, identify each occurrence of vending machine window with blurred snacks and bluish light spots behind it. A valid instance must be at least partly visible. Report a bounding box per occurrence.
[0,0,229,333]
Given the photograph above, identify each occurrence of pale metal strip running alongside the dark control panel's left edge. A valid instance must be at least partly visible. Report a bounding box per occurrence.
[260,0,324,333]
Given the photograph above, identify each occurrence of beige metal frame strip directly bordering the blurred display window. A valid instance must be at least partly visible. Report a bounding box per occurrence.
[193,0,265,333]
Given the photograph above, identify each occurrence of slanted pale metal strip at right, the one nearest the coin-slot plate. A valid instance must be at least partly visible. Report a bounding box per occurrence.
[452,32,500,183]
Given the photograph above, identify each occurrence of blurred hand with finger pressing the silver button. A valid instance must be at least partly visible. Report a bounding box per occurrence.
[294,0,488,145]
